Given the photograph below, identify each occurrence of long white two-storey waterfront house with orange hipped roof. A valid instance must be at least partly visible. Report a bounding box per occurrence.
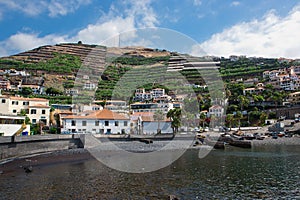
[61,109,130,134]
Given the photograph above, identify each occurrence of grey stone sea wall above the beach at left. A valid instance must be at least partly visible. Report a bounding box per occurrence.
[0,135,83,160]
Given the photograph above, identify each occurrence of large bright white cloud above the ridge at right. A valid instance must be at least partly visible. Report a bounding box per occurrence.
[200,5,300,58]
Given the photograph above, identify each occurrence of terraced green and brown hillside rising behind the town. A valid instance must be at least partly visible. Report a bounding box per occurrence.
[0,43,294,102]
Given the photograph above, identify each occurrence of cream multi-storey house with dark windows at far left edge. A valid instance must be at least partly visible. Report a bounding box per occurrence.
[0,96,50,125]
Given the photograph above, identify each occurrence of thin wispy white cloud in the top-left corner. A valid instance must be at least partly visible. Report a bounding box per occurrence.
[0,0,91,17]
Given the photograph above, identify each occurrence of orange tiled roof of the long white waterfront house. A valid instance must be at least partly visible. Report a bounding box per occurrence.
[64,109,129,120]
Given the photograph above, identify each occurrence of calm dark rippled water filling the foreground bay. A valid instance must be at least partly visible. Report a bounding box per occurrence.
[0,146,300,199]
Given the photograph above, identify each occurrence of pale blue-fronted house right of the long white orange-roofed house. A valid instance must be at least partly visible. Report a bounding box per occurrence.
[130,112,173,135]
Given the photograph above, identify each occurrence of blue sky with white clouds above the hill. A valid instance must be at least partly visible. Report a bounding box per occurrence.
[0,0,300,58]
